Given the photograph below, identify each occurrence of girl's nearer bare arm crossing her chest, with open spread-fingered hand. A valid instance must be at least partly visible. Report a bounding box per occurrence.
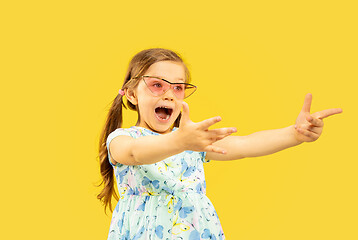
[109,102,236,165]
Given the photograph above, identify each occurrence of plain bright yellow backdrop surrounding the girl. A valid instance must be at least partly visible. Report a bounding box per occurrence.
[0,0,358,240]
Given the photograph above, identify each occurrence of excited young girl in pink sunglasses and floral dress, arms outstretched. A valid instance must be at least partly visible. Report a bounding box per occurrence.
[97,48,342,240]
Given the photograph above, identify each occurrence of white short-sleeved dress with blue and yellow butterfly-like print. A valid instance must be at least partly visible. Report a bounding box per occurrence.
[107,126,225,240]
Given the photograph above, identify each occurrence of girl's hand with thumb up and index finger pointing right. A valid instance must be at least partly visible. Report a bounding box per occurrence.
[294,93,342,142]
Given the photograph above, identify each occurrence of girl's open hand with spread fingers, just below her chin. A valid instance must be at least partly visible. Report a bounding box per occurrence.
[176,102,237,154]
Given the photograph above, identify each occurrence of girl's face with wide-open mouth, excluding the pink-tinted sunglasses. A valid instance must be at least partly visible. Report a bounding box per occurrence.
[127,61,185,134]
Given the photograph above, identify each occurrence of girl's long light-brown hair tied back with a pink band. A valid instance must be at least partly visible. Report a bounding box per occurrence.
[97,48,191,215]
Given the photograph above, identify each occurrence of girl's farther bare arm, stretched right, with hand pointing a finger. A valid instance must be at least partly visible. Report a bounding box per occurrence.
[206,93,342,160]
